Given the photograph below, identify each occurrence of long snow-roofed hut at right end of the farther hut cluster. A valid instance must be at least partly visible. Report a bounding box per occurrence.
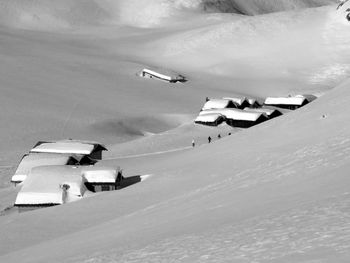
[264,95,310,110]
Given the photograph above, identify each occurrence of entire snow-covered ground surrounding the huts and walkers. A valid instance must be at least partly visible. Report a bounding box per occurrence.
[0,0,350,263]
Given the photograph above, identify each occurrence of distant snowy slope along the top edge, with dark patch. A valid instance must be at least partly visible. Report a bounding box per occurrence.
[0,0,335,30]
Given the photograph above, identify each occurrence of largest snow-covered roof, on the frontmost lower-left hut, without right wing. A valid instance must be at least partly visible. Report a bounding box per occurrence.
[15,165,86,205]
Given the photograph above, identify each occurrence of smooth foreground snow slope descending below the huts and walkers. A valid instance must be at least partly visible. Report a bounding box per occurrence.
[0,72,350,262]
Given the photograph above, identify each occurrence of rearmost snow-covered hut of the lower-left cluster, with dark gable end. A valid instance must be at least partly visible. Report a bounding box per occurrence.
[30,140,107,162]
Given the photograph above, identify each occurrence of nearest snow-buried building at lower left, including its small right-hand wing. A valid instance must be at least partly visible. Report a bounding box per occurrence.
[15,165,123,209]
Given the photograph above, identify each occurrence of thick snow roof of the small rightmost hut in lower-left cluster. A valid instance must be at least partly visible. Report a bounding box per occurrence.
[82,166,117,183]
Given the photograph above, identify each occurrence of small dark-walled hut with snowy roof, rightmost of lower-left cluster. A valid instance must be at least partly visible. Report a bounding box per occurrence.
[82,166,123,192]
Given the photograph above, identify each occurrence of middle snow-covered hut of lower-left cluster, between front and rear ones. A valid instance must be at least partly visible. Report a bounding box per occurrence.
[11,153,79,184]
